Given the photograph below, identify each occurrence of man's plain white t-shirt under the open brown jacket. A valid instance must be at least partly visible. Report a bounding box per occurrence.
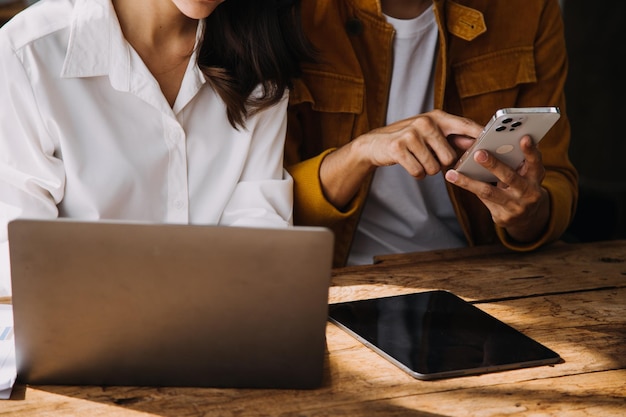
[348,6,466,265]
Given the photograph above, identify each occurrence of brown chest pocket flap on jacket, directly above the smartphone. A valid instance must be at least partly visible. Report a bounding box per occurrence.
[453,46,537,99]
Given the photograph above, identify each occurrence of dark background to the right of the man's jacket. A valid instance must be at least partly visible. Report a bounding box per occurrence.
[563,0,626,241]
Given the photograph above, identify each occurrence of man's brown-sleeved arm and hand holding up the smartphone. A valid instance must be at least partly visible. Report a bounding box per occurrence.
[446,2,577,245]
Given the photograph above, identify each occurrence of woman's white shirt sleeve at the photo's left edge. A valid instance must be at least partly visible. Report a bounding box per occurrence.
[0,36,64,295]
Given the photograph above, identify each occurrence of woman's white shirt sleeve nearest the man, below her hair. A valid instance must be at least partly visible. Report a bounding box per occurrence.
[220,94,293,227]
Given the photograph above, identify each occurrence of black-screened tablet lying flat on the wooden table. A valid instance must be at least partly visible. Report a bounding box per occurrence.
[329,290,562,380]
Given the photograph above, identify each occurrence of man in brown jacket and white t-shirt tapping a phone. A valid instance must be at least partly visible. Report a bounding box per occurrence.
[285,0,578,266]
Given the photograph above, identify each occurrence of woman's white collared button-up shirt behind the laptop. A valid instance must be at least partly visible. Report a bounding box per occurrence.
[0,0,293,295]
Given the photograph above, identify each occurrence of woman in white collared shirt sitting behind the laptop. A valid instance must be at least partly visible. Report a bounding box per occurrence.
[0,0,308,293]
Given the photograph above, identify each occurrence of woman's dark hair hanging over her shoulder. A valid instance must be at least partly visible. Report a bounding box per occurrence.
[198,0,315,128]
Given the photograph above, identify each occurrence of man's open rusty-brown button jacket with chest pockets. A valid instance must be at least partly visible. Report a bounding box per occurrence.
[285,0,578,266]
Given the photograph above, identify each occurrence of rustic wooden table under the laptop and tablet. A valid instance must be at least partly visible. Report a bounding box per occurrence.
[0,241,626,417]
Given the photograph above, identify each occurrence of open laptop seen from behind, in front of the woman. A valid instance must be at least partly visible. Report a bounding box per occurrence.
[8,219,333,389]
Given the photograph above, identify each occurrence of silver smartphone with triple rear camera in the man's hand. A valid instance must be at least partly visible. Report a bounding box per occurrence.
[454,106,561,182]
